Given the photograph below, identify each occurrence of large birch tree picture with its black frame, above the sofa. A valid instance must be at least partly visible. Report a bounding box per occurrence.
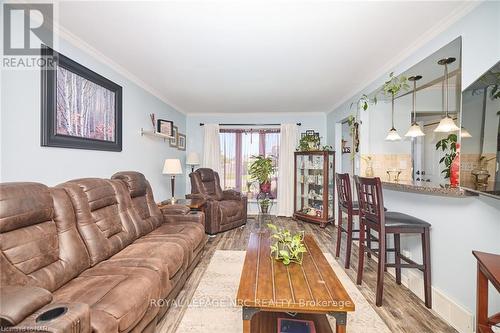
[42,47,122,151]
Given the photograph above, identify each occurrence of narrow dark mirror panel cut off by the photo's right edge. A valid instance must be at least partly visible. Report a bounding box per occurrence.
[460,62,500,199]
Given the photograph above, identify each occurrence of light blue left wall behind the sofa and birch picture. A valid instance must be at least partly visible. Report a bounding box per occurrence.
[0,26,186,201]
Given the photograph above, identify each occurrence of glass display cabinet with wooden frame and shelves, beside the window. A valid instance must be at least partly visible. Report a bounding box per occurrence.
[293,151,335,228]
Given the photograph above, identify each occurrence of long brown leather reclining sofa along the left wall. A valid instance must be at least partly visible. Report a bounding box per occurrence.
[0,172,206,333]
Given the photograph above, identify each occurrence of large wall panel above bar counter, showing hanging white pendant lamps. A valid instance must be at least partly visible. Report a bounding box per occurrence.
[360,37,462,187]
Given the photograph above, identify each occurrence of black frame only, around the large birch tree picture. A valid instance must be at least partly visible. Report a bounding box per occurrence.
[41,46,122,152]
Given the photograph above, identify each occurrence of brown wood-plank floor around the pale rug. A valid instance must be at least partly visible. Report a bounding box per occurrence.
[158,217,457,333]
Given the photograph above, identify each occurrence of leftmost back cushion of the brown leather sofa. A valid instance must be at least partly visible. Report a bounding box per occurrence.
[0,183,89,291]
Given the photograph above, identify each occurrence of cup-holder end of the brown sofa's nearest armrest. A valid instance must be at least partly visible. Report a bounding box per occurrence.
[12,303,92,333]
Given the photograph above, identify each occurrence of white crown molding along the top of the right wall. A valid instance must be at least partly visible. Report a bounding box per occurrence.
[326,0,483,114]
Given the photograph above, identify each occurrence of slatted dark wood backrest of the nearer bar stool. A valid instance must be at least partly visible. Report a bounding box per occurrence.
[354,176,385,229]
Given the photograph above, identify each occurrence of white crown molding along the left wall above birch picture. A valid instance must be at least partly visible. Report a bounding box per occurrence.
[54,20,187,115]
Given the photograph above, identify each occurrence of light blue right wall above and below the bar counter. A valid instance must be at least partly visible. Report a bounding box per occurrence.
[327,2,500,320]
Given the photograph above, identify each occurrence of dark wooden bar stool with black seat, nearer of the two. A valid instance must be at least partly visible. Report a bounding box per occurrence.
[354,176,432,308]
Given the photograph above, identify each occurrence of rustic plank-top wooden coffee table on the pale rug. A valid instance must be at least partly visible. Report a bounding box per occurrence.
[236,232,354,333]
